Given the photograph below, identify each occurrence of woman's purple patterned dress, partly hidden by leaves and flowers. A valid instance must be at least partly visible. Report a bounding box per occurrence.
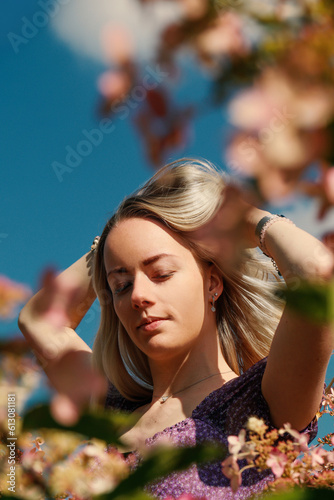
[106,358,317,500]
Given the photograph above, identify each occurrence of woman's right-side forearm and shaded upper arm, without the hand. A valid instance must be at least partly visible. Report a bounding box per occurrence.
[253,209,334,430]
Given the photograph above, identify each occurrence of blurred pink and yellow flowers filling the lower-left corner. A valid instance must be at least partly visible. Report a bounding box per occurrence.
[0,339,130,499]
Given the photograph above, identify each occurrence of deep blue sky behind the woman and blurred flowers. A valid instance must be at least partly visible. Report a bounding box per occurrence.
[0,0,334,438]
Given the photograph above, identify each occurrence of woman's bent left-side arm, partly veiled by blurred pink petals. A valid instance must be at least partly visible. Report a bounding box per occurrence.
[18,252,96,396]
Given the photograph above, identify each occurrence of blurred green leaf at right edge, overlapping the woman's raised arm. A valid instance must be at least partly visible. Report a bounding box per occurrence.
[278,281,334,323]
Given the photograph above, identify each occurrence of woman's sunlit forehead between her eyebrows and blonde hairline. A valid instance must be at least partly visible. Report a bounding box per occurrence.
[104,217,192,267]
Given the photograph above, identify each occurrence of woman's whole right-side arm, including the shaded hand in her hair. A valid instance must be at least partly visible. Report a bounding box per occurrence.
[188,187,334,430]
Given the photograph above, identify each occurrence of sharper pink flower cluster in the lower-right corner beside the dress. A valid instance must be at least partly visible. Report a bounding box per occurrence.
[222,406,334,492]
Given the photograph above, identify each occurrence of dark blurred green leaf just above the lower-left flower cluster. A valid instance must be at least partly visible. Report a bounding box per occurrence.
[22,405,137,446]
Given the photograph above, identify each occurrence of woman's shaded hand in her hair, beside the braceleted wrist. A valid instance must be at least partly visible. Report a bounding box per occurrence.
[187,185,271,269]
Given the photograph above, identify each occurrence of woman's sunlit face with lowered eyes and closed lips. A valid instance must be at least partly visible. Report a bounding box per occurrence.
[104,218,219,360]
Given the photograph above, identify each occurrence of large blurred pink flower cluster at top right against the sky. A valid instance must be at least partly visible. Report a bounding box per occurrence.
[94,0,334,224]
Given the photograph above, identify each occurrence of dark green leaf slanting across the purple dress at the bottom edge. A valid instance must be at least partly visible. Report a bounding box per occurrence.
[97,445,227,500]
